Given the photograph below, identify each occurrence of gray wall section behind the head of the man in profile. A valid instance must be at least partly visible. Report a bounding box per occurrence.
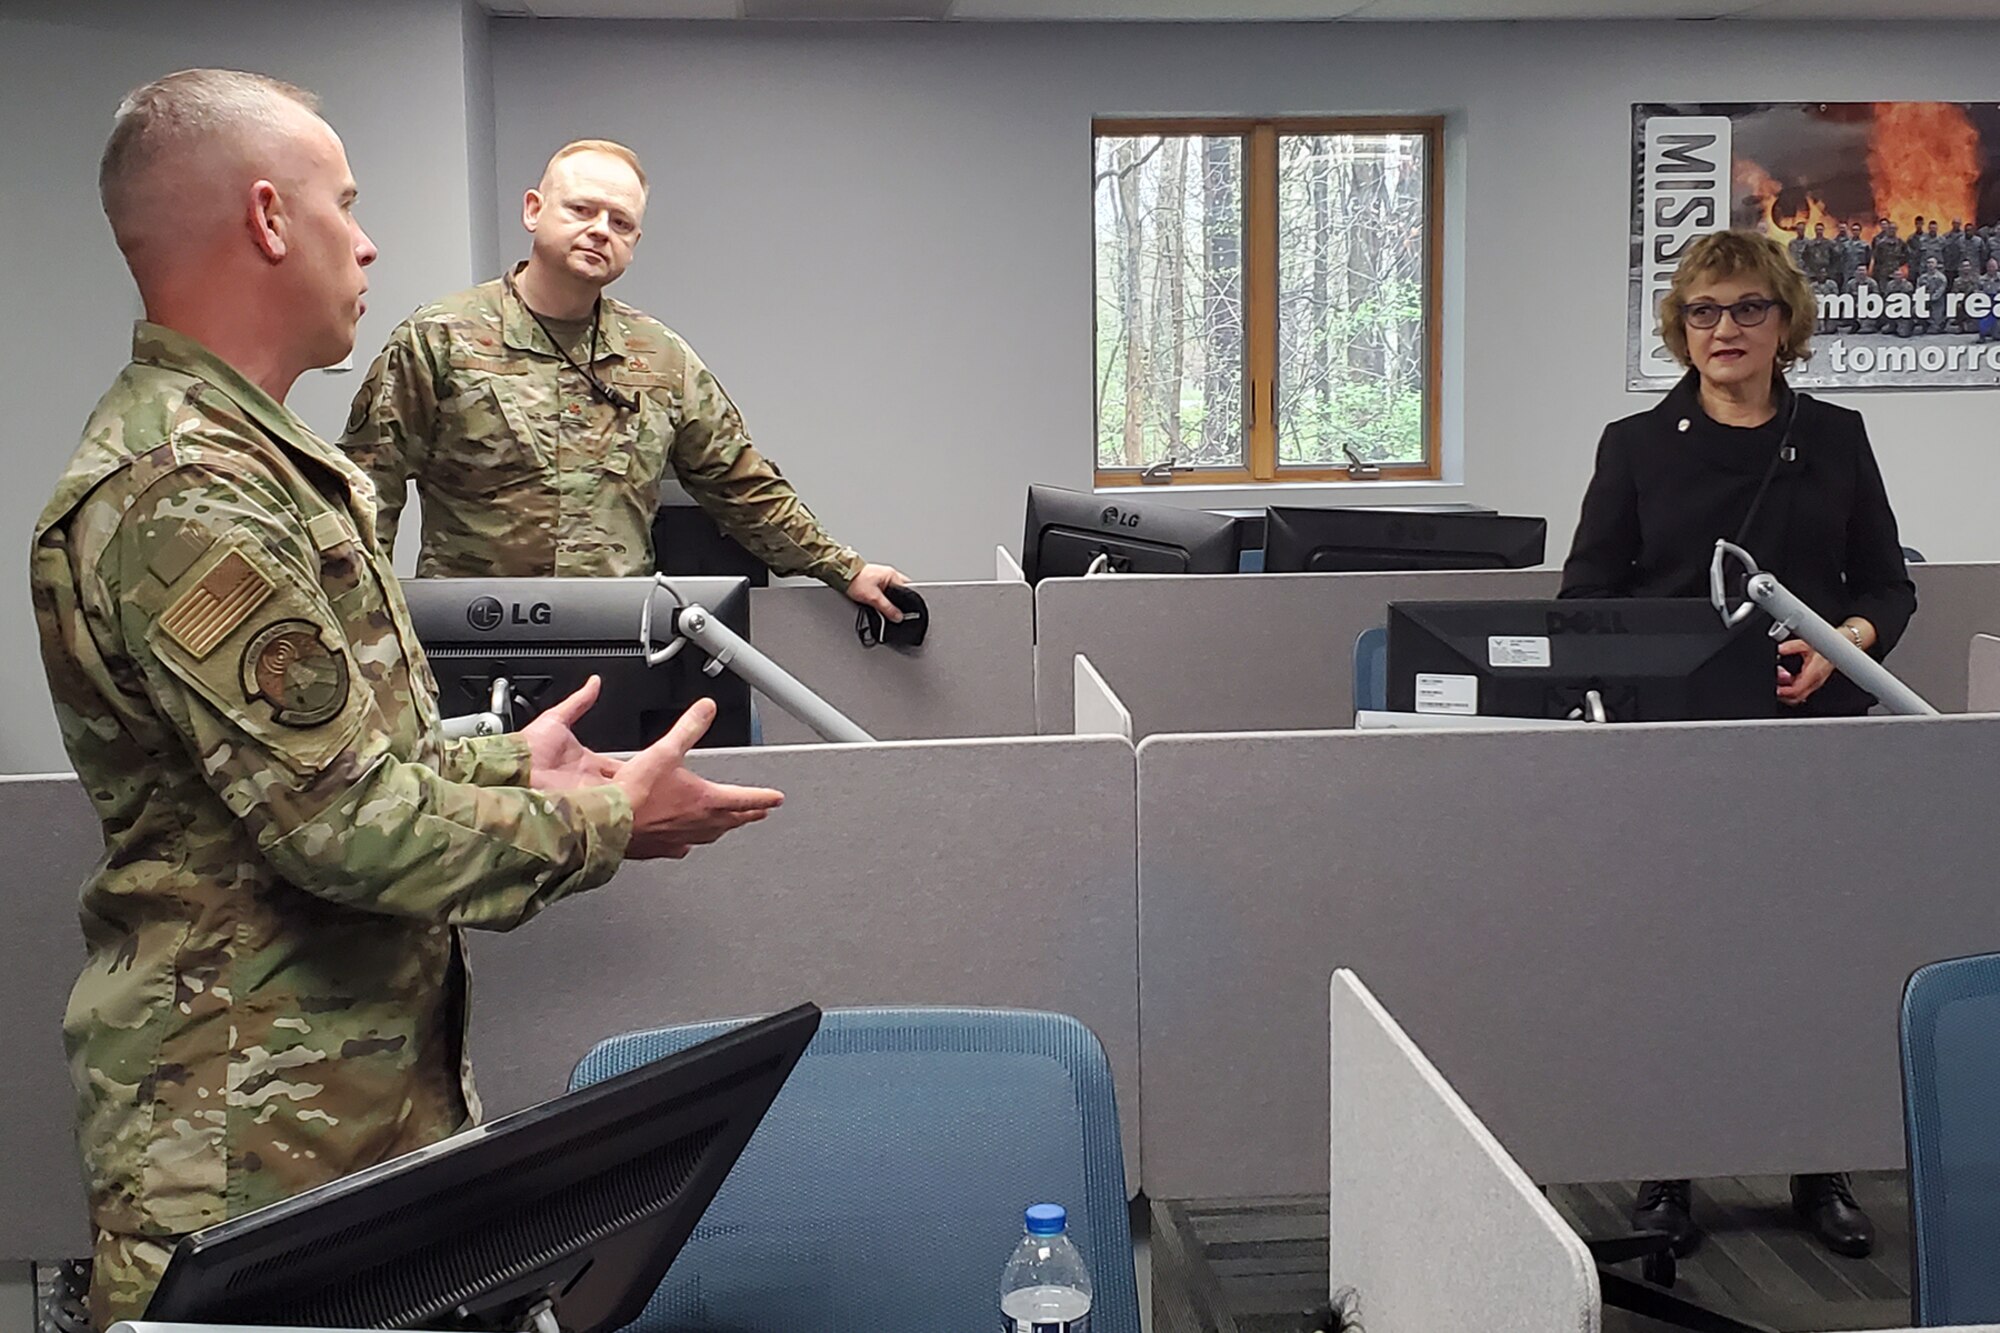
[0,0,486,773]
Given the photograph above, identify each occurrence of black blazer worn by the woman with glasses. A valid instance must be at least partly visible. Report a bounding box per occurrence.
[1560,370,1916,717]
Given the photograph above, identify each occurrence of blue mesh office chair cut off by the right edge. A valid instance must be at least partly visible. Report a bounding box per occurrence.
[1902,953,2000,1327]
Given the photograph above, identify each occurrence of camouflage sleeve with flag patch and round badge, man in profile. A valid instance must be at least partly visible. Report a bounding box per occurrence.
[106,460,632,931]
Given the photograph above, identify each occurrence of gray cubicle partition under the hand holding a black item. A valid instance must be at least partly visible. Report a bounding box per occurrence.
[750,582,1036,745]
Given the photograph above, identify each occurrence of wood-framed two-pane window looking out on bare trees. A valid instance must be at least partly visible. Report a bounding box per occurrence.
[1092,116,1444,486]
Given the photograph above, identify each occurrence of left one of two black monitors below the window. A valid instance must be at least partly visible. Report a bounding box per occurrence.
[1020,486,1240,582]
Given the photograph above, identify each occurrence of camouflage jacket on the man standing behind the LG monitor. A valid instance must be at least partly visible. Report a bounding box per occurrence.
[340,270,862,588]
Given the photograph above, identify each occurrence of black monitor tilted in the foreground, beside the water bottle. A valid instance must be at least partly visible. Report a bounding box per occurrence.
[146,1005,820,1333]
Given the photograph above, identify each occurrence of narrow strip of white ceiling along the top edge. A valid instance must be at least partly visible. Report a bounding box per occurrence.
[484,0,2000,22]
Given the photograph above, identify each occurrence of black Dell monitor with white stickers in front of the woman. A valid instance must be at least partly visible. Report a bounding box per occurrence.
[1388,598,1778,723]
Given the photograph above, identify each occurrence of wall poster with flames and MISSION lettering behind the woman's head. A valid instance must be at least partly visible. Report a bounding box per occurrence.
[1626,102,2000,388]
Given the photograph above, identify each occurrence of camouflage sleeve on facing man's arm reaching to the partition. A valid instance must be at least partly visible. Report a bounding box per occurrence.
[668,348,862,592]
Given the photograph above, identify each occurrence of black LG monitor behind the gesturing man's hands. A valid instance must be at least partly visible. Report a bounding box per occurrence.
[402,578,750,753]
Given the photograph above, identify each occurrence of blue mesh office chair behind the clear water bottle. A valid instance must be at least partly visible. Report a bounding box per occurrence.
[570,1009,1140,1333]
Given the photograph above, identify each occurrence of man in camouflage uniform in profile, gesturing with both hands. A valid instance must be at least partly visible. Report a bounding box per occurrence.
[45,70,776,1327]
